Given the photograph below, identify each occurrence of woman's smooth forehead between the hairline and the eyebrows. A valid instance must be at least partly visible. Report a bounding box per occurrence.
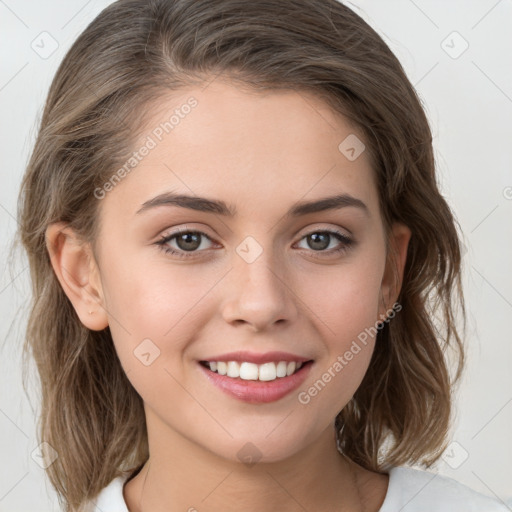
[97,79,377,223]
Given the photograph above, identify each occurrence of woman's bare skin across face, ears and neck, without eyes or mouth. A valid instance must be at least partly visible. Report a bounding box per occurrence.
[47,77,411,512]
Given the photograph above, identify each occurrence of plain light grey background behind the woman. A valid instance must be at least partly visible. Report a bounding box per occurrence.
[0,0,512,512]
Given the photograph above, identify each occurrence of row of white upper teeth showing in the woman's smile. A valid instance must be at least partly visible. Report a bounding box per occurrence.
[207,361,302,381]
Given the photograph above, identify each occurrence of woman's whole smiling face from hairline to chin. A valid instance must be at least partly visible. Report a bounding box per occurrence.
[53,80,408,461]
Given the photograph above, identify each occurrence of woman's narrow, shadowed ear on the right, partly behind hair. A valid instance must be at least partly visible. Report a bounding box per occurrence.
[379,222,411,320]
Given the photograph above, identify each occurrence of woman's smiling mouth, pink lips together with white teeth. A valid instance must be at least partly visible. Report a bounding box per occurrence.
[198,354,314,404]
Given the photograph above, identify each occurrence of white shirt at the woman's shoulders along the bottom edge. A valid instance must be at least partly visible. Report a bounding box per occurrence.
[91,467,510,512]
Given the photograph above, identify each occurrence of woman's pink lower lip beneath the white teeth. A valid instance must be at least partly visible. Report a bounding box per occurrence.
[199,361,312,404]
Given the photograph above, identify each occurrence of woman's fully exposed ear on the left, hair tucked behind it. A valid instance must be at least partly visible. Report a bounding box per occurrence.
[46,222,108,331]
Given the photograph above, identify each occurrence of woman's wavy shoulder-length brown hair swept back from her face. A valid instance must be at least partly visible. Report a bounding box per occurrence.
[14,0,465,511]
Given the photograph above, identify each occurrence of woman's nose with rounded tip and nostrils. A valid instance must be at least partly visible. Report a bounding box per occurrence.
[222,247,298,331]
